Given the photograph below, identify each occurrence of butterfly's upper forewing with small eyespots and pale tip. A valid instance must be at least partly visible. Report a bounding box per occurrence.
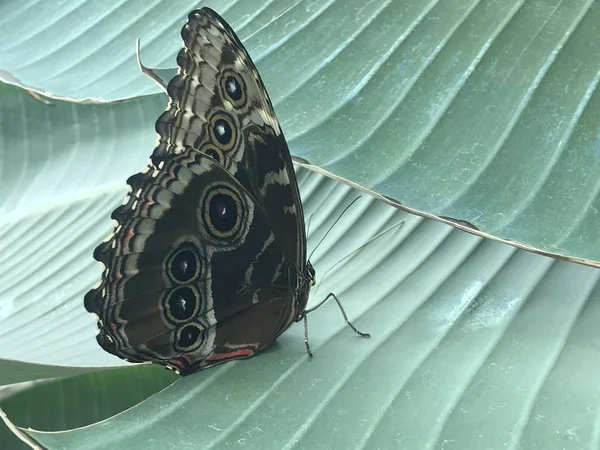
[154,8,306,273]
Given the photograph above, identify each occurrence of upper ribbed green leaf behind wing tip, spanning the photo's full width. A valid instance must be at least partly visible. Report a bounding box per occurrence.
[0,0,600,265]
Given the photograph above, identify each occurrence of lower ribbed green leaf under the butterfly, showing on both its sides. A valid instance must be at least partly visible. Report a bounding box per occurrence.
[0,81,600,449]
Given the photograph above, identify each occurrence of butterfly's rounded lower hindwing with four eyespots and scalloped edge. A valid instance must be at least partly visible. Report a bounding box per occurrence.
[85,149,298,370]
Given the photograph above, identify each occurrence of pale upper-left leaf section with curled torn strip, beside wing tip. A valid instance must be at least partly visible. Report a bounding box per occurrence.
[0,0,225,101]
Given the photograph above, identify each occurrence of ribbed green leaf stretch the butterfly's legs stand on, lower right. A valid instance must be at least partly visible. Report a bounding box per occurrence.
[5,174,600,450]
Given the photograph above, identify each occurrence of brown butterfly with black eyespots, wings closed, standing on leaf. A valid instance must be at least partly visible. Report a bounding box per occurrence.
[84,8,362,375]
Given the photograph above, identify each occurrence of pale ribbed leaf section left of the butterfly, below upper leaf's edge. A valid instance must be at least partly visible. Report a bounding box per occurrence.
[0,85,164,370]
